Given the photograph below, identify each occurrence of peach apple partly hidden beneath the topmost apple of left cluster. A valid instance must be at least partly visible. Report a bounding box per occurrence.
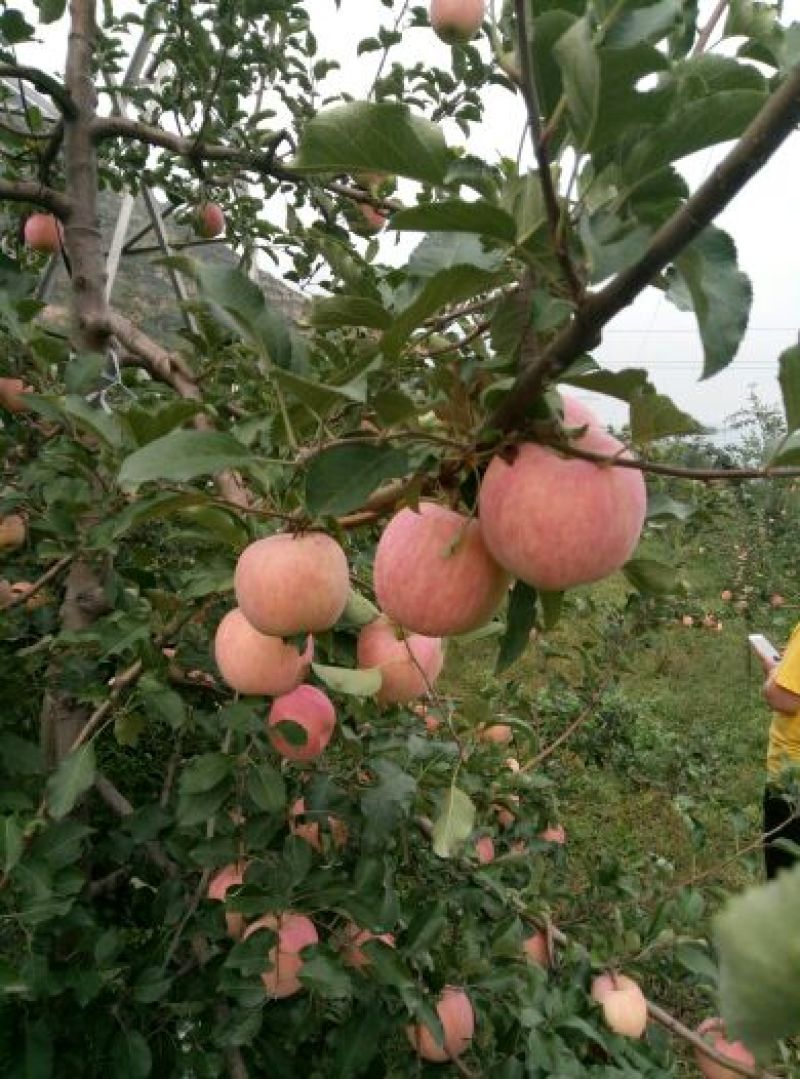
[214,607,314,697]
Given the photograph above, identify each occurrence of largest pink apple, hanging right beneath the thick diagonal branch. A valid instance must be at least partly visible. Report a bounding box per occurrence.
[478,397,647,591]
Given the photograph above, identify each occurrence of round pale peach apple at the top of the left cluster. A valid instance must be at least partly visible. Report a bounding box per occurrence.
[233,532,350,637]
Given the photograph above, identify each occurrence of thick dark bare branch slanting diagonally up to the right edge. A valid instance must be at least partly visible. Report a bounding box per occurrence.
[487,67,800,431]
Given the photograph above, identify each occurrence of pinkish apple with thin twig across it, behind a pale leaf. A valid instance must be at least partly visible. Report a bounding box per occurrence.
[357,616,444,705]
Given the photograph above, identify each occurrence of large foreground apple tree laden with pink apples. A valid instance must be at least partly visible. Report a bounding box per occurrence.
[0,0,800,1079]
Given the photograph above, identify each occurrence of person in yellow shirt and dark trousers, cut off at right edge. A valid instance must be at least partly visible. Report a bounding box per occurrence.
[761,623,800,879]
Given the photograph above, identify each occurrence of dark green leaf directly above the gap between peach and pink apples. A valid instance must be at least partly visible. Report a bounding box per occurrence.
[306,442,410,516]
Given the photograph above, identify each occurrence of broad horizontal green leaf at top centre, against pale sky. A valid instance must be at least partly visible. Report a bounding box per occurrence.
[290,101,448,183]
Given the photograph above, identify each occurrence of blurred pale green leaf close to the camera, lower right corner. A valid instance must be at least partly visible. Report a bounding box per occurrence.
[714,866,800,1056]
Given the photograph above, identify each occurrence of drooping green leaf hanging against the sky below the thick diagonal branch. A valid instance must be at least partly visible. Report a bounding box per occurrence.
[667,227,752,379]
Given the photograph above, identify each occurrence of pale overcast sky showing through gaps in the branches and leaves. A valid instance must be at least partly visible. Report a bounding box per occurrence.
[10,0,800,427]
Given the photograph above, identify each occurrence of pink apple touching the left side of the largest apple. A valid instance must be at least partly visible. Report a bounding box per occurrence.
[374,502,509,637]
